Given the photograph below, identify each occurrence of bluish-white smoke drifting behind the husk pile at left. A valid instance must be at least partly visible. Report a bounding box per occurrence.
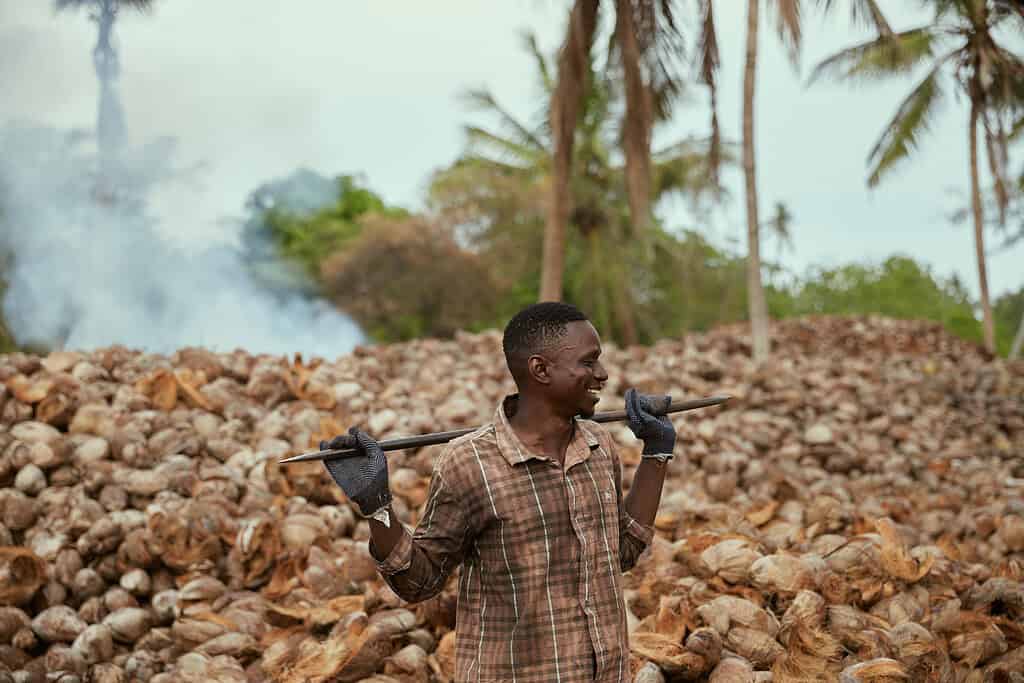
[0,124,365,358]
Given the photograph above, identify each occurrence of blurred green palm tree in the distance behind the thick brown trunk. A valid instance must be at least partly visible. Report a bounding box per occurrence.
[431,36,722,344]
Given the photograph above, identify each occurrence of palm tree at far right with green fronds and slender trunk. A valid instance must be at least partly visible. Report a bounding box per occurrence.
[810,0,1024,352]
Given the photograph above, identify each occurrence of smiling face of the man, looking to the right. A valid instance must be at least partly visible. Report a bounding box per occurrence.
[544,321,608,418]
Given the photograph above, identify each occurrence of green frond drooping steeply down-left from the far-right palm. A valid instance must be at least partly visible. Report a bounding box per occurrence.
[867,59,945,187]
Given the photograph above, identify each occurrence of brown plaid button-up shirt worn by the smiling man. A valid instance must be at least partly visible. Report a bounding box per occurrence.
[378,396,653,683]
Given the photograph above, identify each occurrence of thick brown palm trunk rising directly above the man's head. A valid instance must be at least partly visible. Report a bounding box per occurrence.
[540,0,599,301]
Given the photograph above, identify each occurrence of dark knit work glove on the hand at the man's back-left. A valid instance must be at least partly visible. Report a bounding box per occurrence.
[319,427,391,517]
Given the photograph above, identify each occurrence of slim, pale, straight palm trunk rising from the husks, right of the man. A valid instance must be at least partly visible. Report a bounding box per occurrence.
[743,0,770,362]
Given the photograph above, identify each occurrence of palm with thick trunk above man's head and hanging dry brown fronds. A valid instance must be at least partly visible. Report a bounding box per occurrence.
[540,0,719,301]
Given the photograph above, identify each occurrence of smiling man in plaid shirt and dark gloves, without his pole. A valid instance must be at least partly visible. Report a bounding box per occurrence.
[321,302,676,683]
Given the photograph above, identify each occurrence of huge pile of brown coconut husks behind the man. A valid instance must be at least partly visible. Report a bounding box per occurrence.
[0,317,1024,683]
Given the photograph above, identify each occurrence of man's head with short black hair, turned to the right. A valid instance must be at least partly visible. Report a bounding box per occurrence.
[502,301,608,417]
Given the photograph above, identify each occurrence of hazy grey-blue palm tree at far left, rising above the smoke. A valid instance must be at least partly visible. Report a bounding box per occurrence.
[55,0,153,194]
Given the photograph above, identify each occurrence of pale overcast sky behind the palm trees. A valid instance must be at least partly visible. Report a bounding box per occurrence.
[0,0,1024,295]
